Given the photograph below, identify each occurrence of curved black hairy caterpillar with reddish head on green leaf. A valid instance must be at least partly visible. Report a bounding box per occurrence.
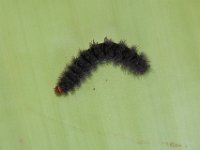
[55,38,150,95]
